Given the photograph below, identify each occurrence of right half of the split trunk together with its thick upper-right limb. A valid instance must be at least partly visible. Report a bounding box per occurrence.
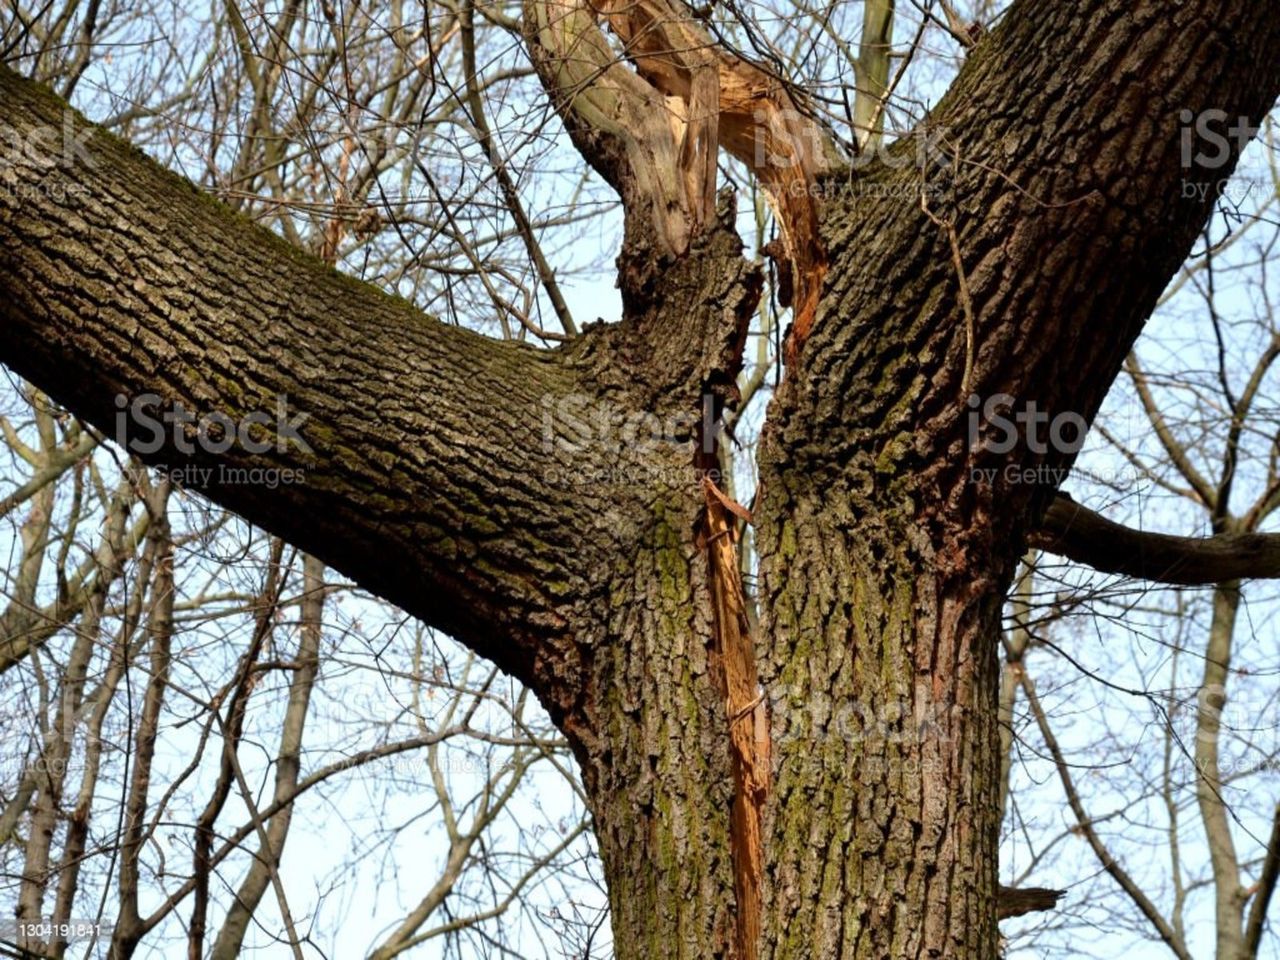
[754,0,1280,960]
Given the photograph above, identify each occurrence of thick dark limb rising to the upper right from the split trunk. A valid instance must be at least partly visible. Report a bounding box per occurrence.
[762,0,1280,570]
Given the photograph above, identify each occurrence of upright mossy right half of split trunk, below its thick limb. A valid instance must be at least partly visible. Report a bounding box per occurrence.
[759,475,1000,960]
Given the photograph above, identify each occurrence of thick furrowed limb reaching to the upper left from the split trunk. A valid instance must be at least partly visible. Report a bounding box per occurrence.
[0,60,754,695]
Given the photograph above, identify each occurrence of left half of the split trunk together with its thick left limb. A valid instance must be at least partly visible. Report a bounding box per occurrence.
[0,56,762,956]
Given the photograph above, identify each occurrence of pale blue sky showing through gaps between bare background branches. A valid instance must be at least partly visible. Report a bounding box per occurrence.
[0,3,1280,960]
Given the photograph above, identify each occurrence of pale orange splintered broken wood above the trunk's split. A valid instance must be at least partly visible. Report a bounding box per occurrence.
[525,0,838,353]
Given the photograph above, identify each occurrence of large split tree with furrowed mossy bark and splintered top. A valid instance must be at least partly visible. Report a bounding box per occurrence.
[0,0,1280,959]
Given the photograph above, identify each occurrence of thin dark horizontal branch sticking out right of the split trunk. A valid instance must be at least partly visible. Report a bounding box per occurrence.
[1030,494,1280,586]
